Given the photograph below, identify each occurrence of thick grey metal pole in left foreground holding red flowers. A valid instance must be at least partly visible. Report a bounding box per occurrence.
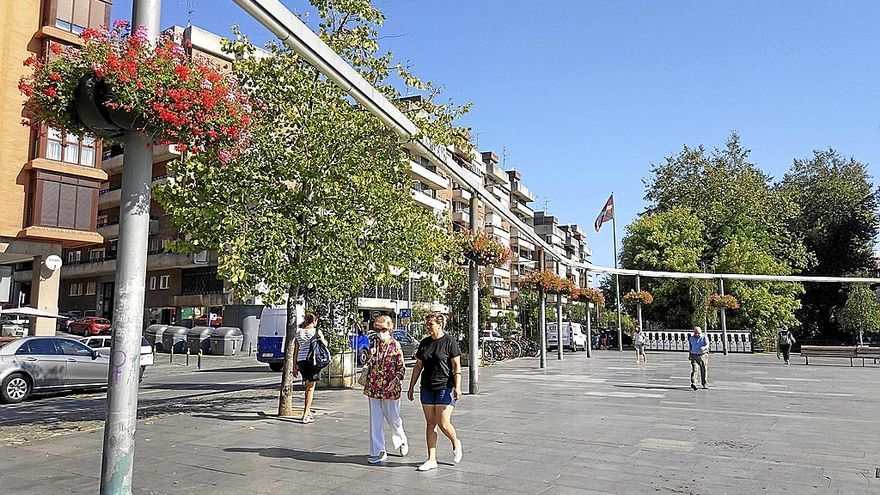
[101,0,162,495]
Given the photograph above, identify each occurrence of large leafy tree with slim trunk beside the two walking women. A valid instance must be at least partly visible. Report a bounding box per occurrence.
[158,0,460,416]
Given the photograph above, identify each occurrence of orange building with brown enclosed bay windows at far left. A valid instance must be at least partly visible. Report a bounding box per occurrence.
[0,0,111,335]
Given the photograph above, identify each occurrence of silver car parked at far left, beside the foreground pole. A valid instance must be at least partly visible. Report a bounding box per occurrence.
[0,337,110,403]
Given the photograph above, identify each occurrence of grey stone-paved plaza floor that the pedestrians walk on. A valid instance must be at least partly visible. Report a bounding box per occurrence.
[0,351,880,495]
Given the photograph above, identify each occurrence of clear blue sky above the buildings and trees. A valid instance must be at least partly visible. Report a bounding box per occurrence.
[113,0,880,272]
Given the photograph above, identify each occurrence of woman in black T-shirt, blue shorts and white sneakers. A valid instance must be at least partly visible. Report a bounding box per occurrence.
[407,313,463,471]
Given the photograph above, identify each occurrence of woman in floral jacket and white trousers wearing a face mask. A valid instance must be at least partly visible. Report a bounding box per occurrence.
[364,316,409,464]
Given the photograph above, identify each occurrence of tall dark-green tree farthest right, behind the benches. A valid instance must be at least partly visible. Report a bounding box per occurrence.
[779,149,880,338]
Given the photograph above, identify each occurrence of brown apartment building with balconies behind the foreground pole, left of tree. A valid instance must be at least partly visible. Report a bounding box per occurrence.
[50,26,229,330]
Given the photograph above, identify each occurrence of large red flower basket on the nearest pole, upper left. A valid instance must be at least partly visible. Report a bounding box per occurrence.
[19,21,252,163]
